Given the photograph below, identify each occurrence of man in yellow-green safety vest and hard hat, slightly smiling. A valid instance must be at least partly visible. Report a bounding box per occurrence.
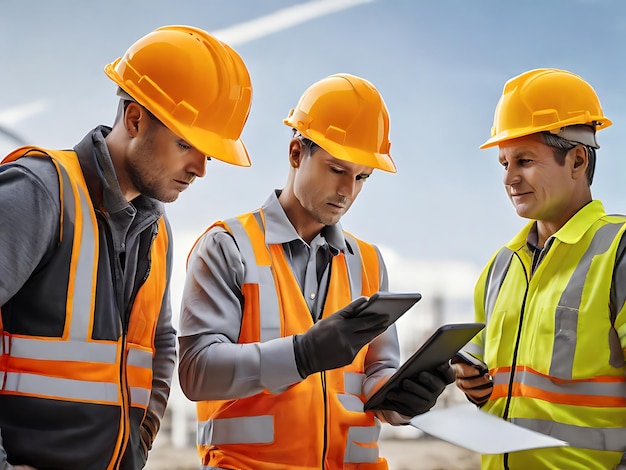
[454,69,626,470]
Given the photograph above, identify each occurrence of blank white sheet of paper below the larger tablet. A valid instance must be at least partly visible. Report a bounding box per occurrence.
[410,403,569,454]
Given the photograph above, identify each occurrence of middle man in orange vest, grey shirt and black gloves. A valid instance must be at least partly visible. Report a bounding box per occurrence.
[179,74,451,470]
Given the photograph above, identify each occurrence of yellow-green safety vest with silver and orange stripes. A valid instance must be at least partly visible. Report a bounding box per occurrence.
[468,201,626,470]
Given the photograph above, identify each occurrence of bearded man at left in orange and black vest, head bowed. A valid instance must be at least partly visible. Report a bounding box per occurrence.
[0,26,251,469]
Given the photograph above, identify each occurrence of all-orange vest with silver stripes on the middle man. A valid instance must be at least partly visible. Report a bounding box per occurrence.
[197,210,388,470]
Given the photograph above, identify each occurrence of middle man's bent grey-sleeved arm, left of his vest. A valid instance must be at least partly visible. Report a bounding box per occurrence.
[178,228,302,401]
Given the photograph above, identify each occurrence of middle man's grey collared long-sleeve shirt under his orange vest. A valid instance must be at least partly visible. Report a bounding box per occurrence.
[179,191,399,420]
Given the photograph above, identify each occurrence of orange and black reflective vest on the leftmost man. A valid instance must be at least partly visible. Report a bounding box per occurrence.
[0,147,168,469]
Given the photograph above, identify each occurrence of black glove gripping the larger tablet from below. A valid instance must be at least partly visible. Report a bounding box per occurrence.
[376,363,454,418]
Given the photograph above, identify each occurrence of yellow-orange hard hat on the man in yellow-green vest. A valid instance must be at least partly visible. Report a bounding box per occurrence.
[480,69,611,149]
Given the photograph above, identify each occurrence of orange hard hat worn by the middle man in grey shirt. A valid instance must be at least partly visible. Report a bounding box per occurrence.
[283,73,396,173]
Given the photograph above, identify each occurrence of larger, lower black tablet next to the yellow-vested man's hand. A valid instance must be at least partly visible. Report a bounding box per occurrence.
[364,323,485,410]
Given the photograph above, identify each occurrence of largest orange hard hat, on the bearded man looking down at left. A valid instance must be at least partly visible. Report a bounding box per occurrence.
[104,26,252,166]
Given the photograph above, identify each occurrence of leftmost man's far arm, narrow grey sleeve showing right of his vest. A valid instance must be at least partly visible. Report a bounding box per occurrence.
[141,220,176,456]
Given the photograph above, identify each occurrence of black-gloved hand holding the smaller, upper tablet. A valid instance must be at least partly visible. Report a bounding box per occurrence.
[293,297,389,378]
